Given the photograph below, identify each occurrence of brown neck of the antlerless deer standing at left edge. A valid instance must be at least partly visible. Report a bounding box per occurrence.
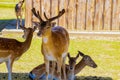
[23,31,33,52]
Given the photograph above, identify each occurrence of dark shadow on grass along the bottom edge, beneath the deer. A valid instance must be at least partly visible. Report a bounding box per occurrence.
[0,73,113,80]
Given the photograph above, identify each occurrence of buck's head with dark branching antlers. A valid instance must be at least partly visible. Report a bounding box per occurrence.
[32,8,65,36]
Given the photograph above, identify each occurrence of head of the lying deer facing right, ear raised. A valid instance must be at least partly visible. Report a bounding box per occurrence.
[78,51,97,68]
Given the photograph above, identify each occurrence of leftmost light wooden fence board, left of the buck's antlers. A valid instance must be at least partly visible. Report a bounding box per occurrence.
[25,0,32,27]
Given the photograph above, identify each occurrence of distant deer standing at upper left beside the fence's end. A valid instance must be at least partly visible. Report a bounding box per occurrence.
[15,0,24,29]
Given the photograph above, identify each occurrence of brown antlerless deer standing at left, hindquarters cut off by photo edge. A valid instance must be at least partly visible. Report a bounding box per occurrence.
[0,25,36,80]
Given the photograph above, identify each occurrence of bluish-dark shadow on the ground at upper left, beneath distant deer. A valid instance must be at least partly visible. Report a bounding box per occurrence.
[0,19,25,31]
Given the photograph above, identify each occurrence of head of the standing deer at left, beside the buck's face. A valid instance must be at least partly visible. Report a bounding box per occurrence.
[20,25,36,39]
